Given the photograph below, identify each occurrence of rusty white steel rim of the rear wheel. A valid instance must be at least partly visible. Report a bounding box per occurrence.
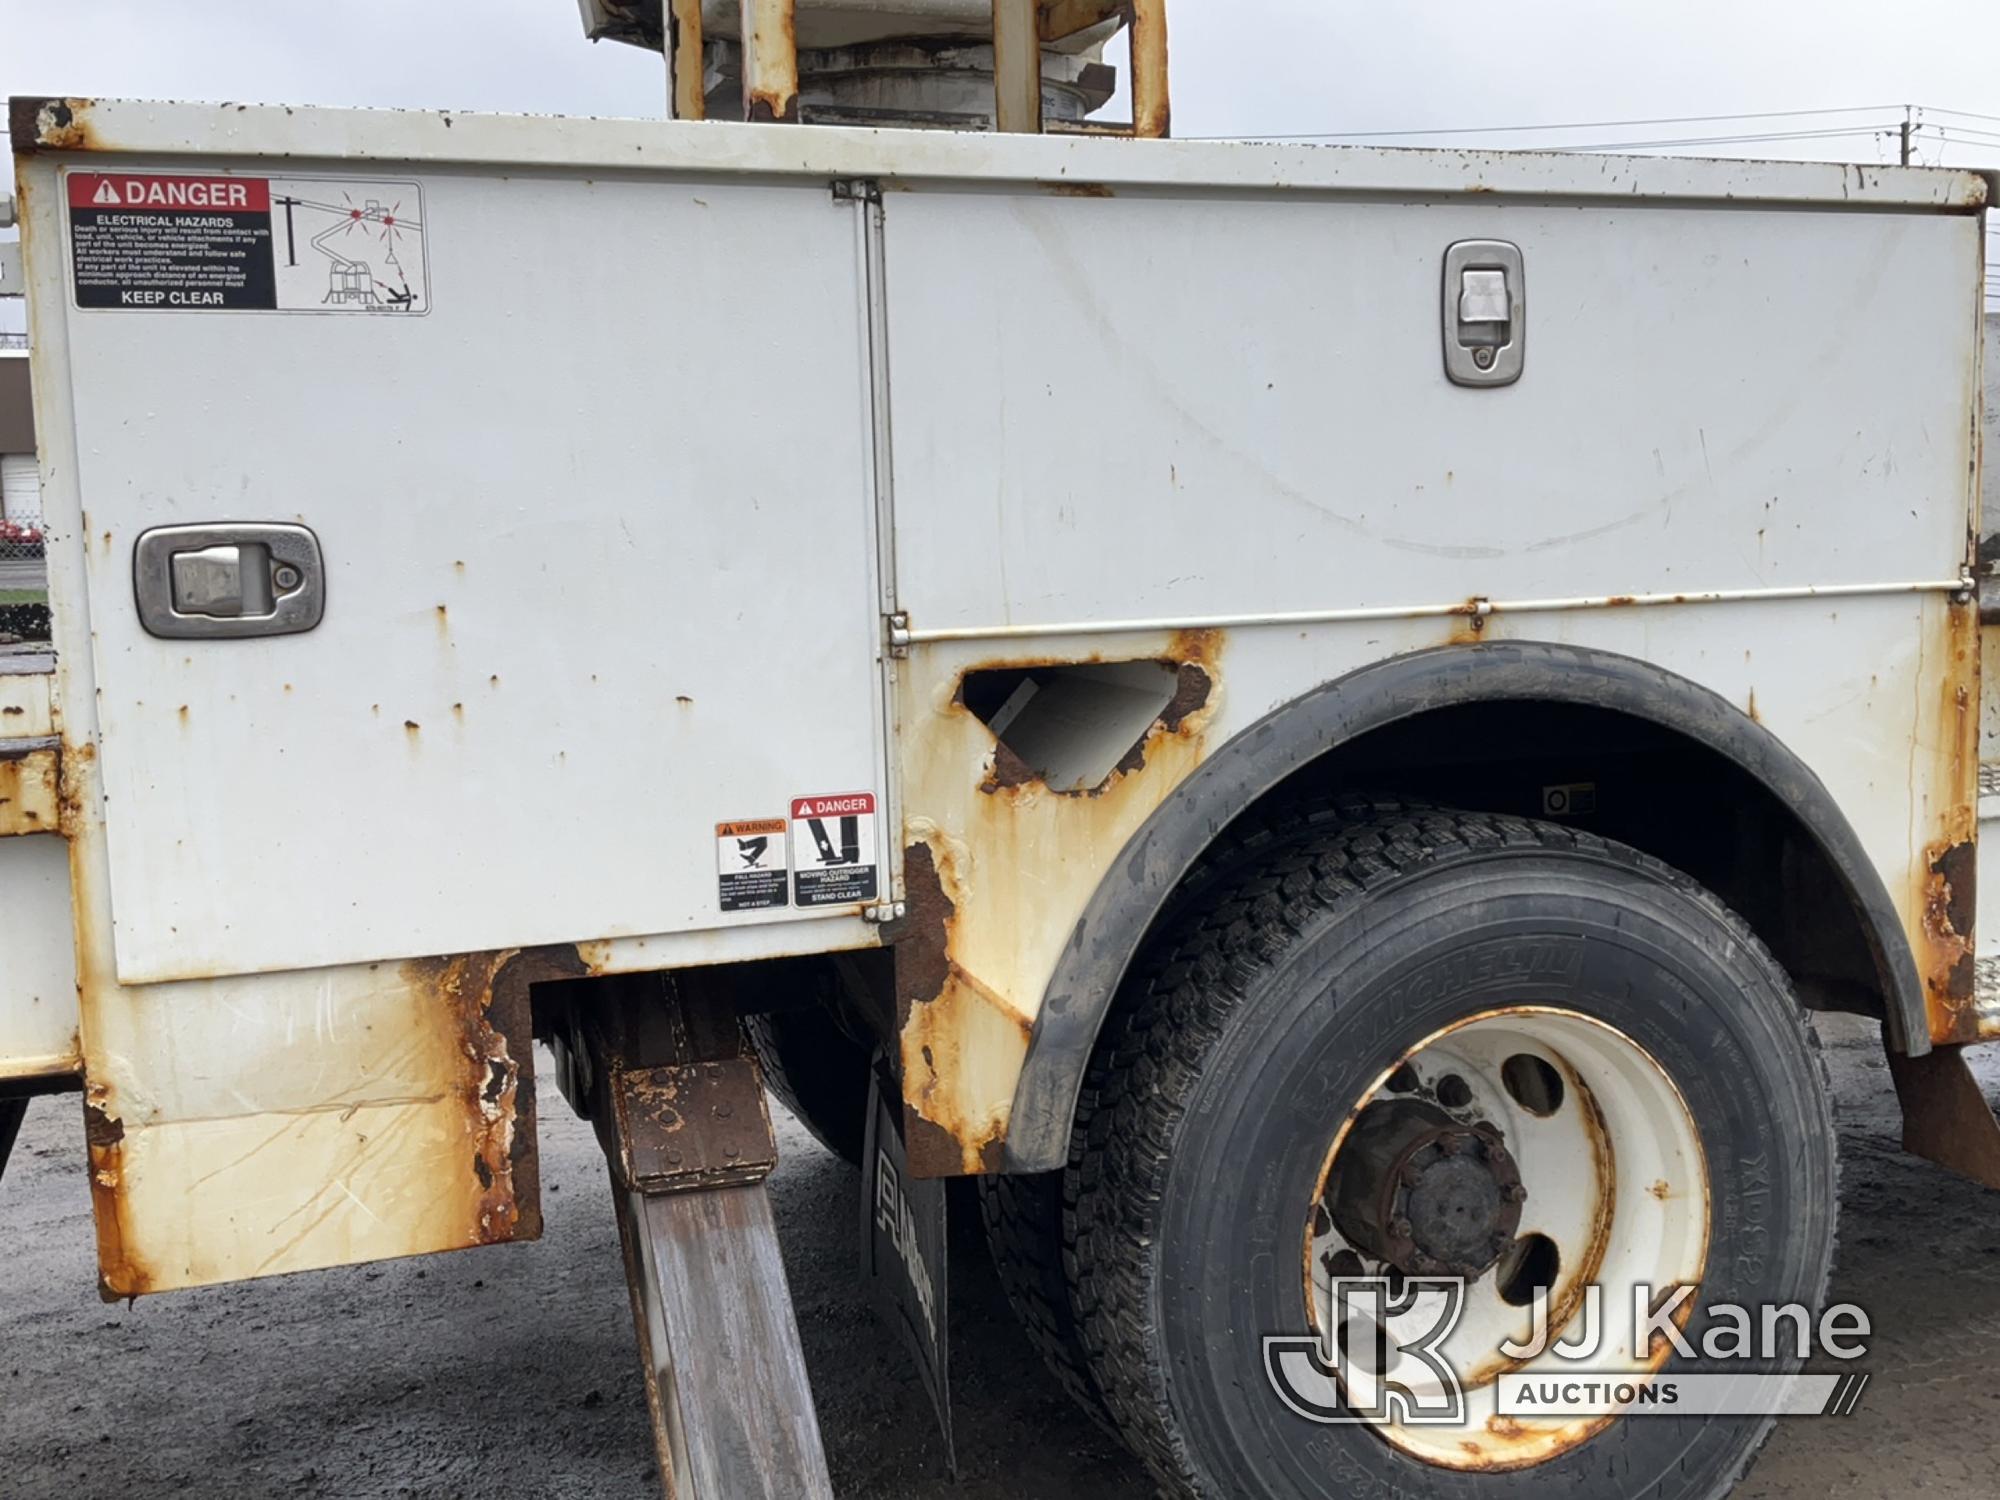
[1306,1006,1710,1470]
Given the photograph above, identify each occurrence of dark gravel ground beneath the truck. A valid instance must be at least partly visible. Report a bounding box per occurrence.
[0,1018,2000,1500]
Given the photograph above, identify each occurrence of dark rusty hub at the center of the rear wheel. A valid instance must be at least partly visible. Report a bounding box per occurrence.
[1328,1100,1528,1280]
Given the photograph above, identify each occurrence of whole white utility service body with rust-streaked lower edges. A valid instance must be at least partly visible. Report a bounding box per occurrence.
[0,88,2000,1500]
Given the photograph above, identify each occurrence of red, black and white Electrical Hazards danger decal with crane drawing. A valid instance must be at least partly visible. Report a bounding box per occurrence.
[68,172,430,314]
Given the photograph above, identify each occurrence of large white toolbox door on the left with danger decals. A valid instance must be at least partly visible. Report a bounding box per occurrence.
[66,160,882,982]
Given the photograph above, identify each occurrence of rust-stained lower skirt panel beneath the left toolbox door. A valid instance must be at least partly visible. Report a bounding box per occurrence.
[86,948,588,1298]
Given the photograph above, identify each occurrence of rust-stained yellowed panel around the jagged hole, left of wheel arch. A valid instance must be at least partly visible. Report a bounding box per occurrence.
[896,630,1224,1176]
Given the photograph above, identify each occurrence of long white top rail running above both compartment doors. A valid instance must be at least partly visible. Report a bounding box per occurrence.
[11,100,1986,210]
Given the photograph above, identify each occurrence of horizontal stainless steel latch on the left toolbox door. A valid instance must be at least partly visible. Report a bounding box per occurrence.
[132,522,326,640]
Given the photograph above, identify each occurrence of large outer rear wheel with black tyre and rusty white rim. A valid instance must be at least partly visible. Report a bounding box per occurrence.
[1064,808,1836,1500]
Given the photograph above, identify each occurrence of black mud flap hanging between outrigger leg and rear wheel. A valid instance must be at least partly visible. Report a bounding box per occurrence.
[862,1054,958,1478]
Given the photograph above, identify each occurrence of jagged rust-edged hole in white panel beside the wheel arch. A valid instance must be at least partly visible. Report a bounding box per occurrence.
[958,658,1210,796]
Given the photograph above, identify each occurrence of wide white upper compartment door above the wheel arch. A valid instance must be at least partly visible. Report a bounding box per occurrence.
[886,192,1980,632]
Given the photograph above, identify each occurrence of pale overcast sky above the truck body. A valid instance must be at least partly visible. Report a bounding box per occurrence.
[0,0,2000,326]
